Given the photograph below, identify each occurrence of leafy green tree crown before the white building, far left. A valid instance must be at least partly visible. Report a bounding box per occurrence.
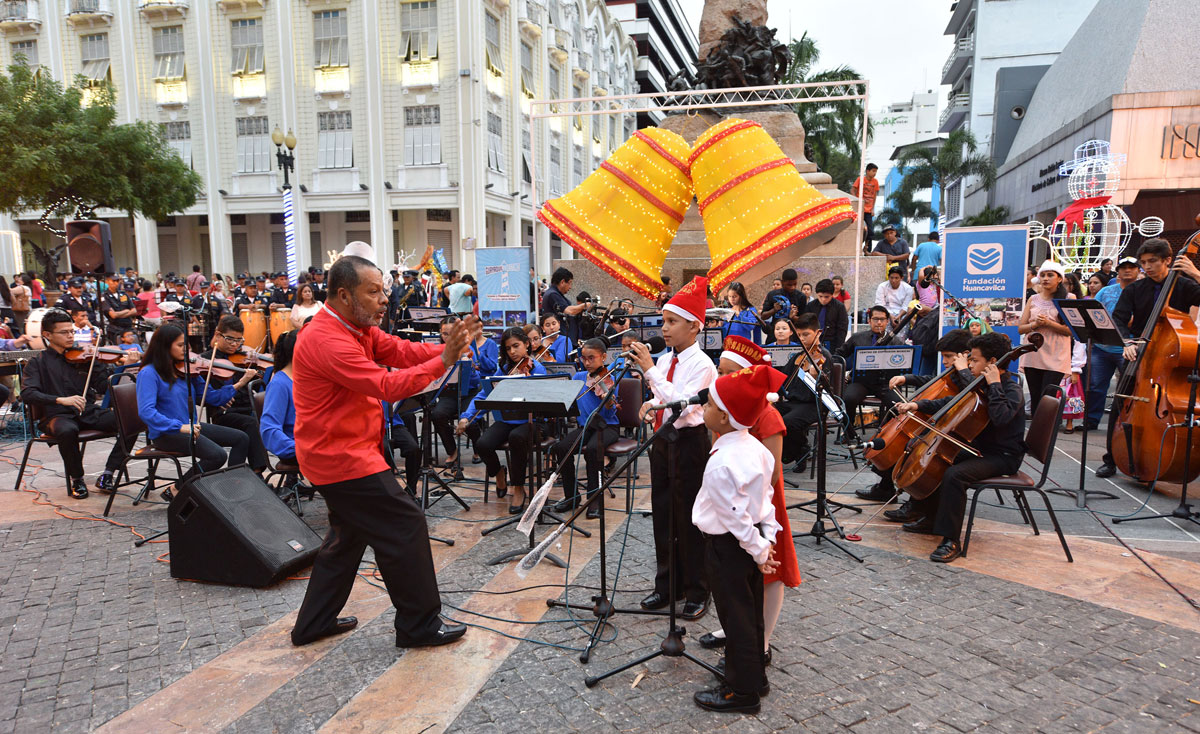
[0,64,203,219]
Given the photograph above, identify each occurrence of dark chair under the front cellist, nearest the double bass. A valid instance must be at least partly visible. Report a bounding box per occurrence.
[962,387,1075,562]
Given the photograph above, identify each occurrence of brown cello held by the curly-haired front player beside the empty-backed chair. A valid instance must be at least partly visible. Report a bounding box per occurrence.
[892,332,1045,500]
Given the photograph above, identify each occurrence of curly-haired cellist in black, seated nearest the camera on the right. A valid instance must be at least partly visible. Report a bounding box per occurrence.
[896,331,1025,564]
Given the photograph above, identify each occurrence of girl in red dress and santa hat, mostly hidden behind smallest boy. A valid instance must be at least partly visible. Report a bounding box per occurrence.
[700,336,800,663]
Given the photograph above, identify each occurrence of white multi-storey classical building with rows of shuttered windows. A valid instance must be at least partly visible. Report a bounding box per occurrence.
[0,0,637,273]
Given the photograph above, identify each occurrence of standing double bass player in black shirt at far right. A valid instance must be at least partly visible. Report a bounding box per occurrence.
[1096,237,1200,479]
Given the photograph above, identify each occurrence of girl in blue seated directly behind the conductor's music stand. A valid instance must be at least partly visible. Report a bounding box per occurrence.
[455,326,546,515]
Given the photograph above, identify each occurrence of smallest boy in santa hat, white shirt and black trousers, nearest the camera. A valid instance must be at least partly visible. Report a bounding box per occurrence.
[691,365,786,714]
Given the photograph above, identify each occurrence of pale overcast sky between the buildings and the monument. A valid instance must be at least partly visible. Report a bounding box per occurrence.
[678,0,952,112]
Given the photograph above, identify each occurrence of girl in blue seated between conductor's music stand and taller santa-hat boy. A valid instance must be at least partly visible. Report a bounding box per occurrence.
[551,339,619,518]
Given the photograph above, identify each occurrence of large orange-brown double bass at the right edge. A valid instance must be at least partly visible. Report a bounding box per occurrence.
[1109,229,1200,483]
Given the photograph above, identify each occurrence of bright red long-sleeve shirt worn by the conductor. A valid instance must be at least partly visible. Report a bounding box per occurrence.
[292,308,445,485]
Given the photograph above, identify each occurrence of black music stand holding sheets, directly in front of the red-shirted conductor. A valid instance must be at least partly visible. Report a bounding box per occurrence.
[475,374,592,568]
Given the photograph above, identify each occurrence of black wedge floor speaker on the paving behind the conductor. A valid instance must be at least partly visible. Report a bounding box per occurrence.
[167,465,322,586]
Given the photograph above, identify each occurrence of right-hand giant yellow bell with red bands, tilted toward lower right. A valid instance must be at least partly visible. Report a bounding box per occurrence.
[689,118,854,293]
